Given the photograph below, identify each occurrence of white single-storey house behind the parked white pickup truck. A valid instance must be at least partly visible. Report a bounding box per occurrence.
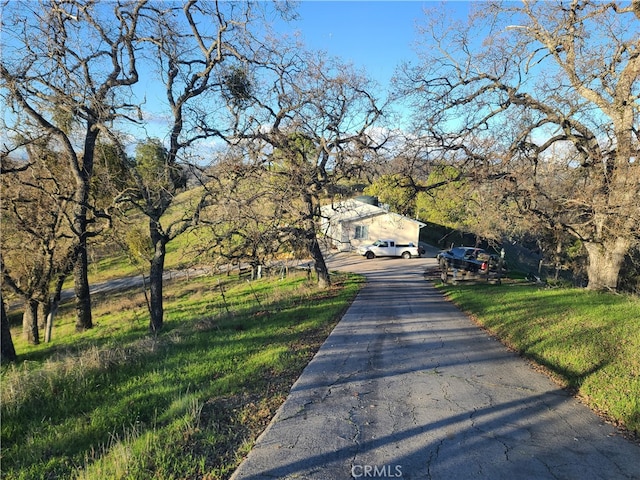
[321,197,426,251]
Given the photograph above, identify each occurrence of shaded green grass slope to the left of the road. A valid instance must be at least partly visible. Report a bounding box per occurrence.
[1,274,361,480]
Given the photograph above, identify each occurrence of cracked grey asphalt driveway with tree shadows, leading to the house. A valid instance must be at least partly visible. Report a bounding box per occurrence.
[232,255,640,480]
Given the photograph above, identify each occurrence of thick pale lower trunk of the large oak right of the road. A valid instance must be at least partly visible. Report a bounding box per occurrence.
[584,237,630,291]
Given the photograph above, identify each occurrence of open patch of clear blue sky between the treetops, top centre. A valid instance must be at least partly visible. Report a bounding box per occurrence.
[277,0,470,87]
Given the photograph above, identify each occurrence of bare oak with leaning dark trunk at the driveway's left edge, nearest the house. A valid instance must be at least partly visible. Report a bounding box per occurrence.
[228,45,382,287]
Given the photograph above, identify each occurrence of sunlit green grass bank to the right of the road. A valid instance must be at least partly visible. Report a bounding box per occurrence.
[441,284,640,435]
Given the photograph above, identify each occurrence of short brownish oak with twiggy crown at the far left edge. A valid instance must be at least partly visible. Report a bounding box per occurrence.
[0,144,75,344]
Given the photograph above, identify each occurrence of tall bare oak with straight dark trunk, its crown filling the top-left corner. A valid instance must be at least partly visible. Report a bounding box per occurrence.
[0,0,146,331]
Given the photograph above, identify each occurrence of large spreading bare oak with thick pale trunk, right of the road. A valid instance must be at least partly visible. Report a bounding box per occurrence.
[405,0,640,289]
